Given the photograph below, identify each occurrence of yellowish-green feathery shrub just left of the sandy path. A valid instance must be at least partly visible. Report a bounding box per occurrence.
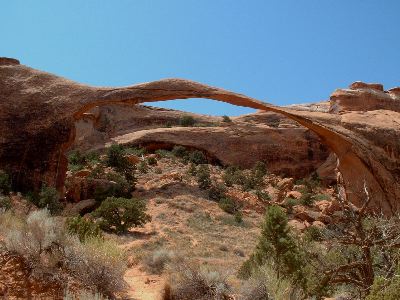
[65,238,126,298]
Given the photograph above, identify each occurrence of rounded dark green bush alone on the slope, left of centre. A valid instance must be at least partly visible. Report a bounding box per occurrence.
[93,197,151,233]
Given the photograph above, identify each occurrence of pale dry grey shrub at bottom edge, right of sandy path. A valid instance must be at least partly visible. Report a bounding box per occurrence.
[164,261,231,300]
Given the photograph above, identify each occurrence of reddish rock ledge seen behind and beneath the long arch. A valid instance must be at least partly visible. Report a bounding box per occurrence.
[75,105,330,178]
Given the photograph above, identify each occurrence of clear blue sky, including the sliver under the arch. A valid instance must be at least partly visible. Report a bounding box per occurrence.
[0,0,400,115]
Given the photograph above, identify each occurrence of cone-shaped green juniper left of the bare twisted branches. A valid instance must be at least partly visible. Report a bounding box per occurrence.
[242,206,305,282]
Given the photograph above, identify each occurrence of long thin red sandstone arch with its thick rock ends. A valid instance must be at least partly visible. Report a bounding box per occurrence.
[0,58,400,214]
